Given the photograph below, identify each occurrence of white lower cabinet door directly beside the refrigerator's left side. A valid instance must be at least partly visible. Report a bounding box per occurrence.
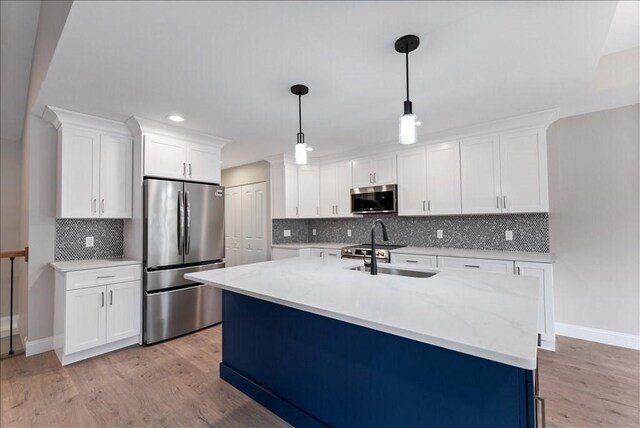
[107,281,142,343]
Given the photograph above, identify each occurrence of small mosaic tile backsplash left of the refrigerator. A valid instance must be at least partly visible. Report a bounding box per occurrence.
[55,218,124,261]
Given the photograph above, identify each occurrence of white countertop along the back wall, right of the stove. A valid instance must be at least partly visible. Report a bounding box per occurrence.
[391,247,555,263]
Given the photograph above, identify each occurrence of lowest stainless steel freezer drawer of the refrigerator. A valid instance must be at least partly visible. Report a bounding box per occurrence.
[144,285,222,344]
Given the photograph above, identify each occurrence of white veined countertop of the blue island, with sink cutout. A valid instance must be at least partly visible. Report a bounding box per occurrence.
[185,257,538,370]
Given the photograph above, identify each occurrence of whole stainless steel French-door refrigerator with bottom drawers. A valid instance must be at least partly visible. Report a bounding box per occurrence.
[143,178,224,344]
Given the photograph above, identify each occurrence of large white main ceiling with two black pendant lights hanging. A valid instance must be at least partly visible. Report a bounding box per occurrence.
[38,1,638,167]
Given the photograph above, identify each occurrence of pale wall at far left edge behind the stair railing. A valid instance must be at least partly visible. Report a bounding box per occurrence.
[0,138,24,326]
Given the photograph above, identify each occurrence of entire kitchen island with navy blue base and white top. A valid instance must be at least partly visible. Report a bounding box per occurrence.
[186,257,538,427]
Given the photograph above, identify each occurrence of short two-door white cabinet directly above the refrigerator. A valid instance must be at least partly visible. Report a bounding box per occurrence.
[144,133,221,184]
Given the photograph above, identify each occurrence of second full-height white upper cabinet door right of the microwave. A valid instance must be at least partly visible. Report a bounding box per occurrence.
[427,142,462,215]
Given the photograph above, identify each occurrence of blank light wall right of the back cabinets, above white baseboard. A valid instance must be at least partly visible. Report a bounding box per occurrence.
[547,104,640,336]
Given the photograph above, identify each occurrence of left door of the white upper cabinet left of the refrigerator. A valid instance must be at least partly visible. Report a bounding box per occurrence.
[58,128,100,218]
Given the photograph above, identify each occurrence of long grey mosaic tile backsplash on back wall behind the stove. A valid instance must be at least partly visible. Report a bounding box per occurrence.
[273,213,549,253]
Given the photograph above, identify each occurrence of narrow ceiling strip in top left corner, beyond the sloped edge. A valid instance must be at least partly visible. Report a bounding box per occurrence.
[0,0,40,140]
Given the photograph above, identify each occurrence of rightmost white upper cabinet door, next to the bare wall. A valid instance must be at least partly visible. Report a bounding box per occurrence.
[500,130,549,213]
